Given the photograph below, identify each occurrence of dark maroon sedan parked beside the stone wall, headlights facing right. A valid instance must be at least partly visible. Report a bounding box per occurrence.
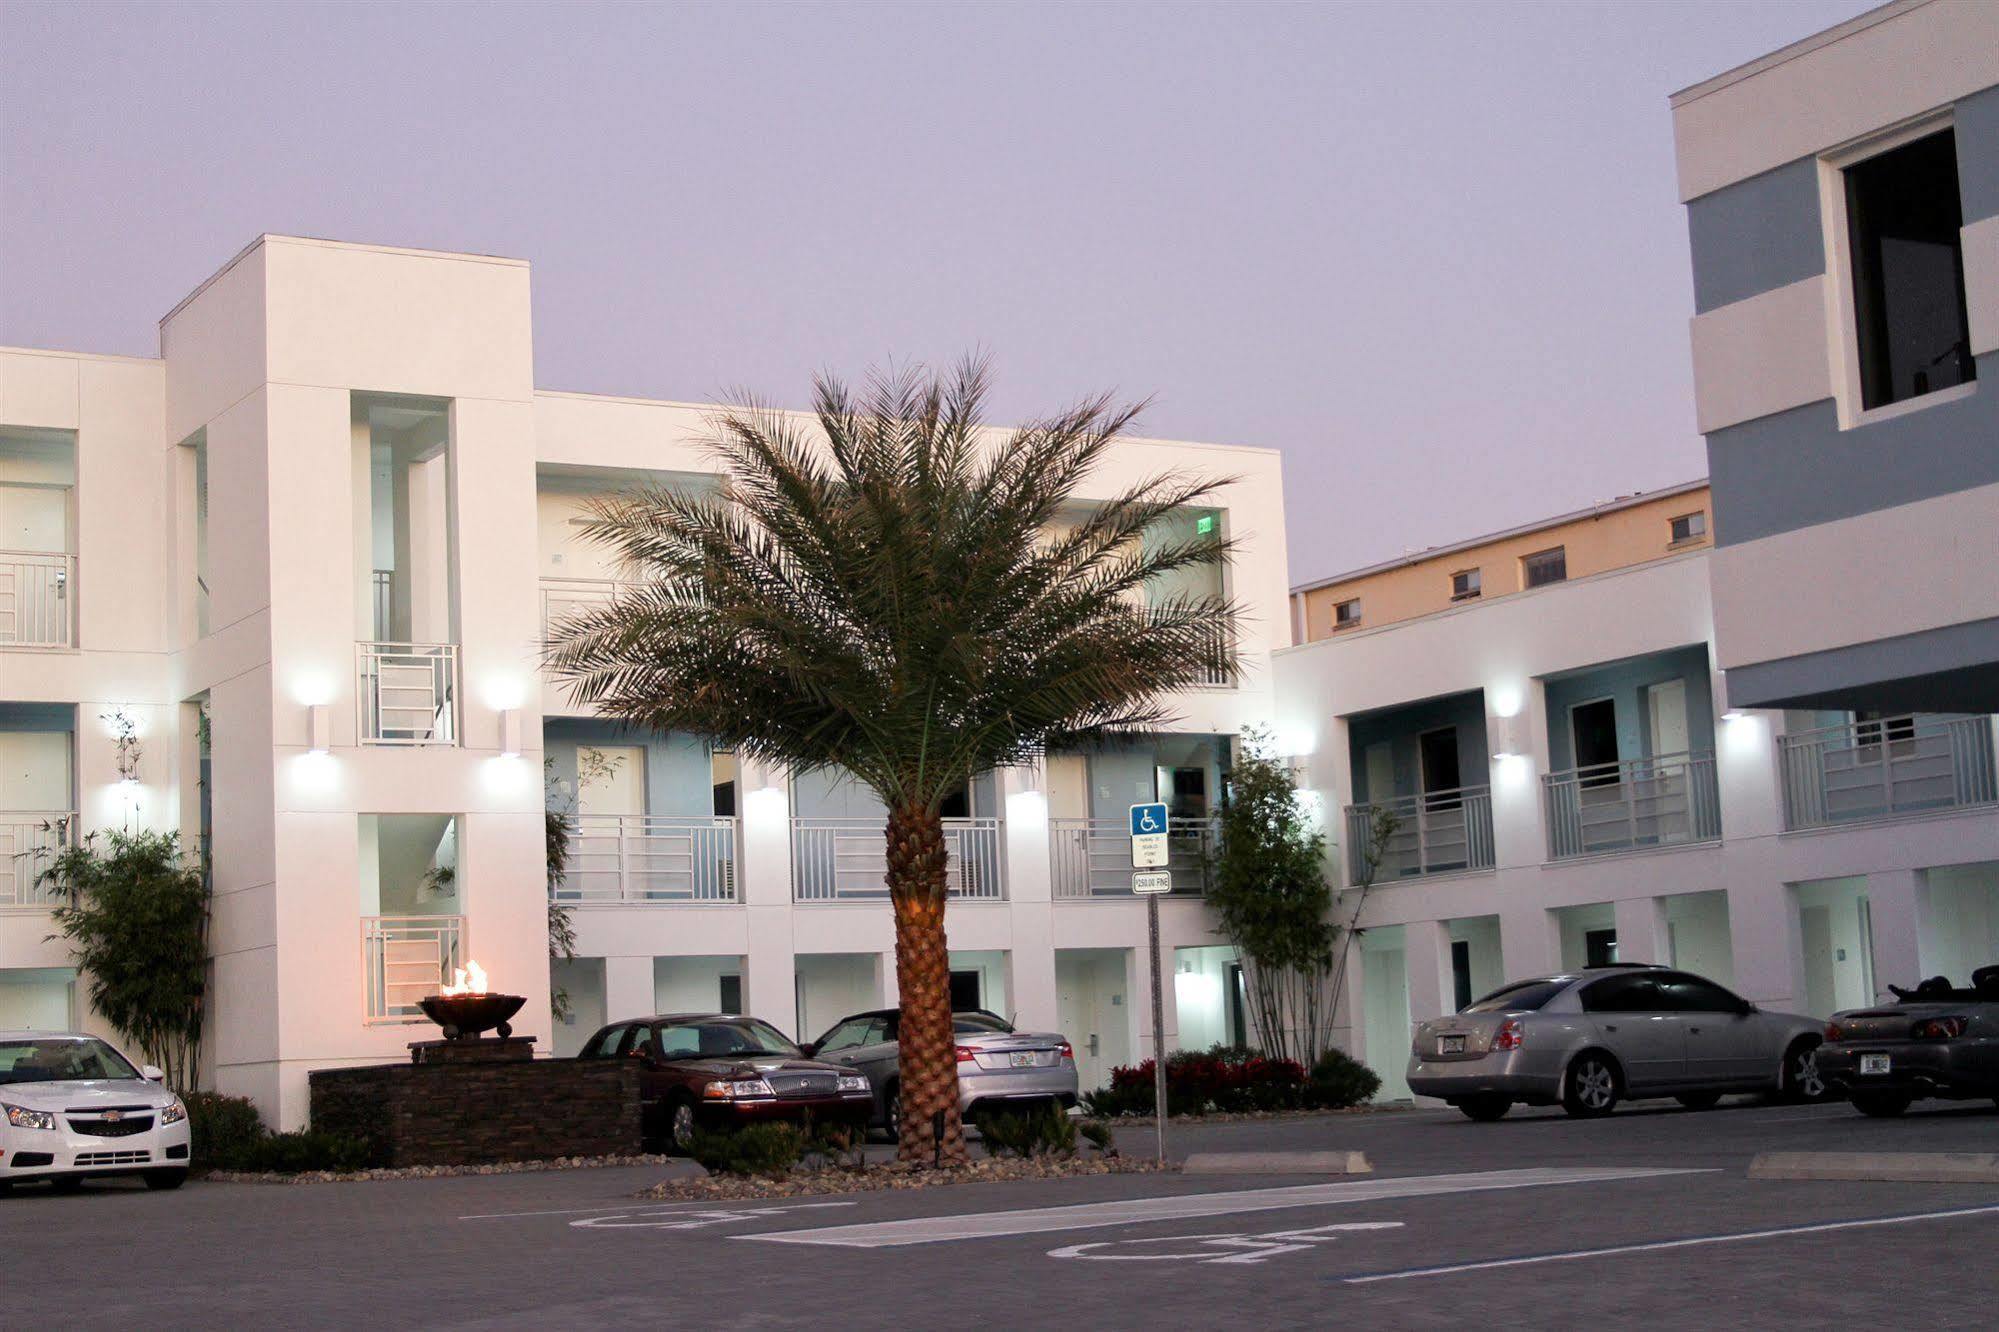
[576,1012,874,1152]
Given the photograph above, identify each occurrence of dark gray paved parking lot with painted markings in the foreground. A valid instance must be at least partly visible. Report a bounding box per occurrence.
[0,1104,1999,1328]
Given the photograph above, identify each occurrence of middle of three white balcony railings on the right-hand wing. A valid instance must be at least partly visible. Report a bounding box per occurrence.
[1541,740,1721,860]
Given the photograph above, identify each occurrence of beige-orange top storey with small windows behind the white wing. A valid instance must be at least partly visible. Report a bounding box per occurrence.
[1291,480,1711,644]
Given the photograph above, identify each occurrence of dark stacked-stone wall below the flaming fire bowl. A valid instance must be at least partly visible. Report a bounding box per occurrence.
[312,1060,642,1166]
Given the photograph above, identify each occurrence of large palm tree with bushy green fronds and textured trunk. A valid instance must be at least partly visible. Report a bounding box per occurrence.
[548,360,1237,1162]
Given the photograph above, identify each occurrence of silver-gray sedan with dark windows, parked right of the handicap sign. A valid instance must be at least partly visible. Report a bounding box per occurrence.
[1409,964,1827,1120]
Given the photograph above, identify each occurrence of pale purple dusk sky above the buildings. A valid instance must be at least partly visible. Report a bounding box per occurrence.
[0,0,1869,582]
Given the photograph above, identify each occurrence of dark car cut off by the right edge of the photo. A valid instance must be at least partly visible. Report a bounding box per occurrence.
[1819,966,1999,1118]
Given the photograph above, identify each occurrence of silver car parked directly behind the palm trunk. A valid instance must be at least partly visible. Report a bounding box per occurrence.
[806,1008,1075,1136]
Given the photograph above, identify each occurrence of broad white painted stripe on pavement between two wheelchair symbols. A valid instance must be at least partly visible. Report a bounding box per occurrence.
[732,1166,1713,1248]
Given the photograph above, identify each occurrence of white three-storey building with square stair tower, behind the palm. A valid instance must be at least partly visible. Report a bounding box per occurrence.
[0,236,1287,1126]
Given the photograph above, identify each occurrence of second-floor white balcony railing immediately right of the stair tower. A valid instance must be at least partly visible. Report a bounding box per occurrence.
[556,814,738,904]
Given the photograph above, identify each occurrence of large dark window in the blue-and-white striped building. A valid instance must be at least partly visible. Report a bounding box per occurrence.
[1845,130,1977,408]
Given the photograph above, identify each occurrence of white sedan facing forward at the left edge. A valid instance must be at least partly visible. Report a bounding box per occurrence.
[0,1032,188,1192]
